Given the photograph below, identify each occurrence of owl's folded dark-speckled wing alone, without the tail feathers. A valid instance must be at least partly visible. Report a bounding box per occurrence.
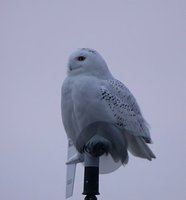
[100,79,151,143]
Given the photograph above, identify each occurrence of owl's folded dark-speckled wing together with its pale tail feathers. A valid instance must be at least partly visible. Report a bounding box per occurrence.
[100,79,156,160]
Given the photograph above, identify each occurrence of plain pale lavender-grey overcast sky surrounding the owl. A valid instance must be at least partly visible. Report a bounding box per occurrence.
[0,0,186,200]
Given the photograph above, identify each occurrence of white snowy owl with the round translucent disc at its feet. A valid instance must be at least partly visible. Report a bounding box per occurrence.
[61,48,155,173]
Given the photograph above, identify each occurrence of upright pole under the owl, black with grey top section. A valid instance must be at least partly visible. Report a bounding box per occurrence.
[83,153,99,200]
